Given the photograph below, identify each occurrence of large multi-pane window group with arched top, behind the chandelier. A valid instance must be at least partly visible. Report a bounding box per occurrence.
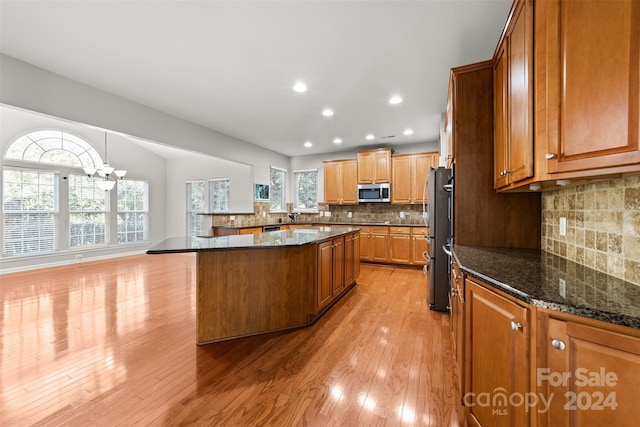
[1,130,148,256]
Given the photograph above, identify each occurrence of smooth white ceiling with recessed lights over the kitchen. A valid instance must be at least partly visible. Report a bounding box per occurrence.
[0,0,511,156]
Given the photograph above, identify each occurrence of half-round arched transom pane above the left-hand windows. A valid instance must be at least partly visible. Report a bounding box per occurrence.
[5,130,102,168]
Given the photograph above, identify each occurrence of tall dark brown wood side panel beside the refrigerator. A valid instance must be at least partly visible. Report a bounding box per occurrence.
[449,61,542,248]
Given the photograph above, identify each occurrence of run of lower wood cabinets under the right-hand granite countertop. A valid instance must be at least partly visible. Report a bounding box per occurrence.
[460,276,640,427]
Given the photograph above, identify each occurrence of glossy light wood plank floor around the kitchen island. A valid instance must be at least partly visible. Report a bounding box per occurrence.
[0,254,462,426]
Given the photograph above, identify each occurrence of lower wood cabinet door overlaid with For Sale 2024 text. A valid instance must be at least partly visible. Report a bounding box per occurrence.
[537,319,640,427]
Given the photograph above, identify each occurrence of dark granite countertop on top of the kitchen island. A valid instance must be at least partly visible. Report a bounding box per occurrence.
[147,227,359,254]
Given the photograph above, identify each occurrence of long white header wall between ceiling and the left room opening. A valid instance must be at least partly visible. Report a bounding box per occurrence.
[0,54,290,187]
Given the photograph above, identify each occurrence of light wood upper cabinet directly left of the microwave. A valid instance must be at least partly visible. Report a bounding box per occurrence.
[323,160,358,205]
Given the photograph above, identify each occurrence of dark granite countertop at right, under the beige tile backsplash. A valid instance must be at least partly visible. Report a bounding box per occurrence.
[454,245,640,329]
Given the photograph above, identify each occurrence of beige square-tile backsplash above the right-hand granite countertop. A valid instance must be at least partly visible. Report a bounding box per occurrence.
[542,176,640,286]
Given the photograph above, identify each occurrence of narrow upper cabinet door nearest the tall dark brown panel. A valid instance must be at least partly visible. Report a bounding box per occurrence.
[493,41,509,188]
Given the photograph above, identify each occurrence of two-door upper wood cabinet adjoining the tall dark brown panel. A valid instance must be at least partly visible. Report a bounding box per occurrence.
[493,0,533,188]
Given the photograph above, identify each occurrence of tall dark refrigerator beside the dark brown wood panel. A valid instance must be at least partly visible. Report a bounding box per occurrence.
[424,167,453,311]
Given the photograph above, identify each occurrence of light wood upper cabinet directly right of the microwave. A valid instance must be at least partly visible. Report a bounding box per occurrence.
[391,152,438,204]
